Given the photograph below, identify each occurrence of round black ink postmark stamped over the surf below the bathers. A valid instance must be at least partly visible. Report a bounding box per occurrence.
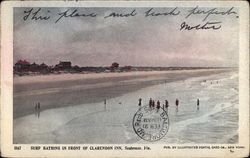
[133,106,169,142]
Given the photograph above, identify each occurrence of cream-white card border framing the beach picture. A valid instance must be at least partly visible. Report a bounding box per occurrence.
[1,1,249,157]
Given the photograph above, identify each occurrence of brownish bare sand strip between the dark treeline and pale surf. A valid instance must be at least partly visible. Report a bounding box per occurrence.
[13,69,232,118]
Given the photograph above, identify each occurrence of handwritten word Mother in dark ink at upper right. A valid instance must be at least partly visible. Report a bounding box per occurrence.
[180,21,221,31]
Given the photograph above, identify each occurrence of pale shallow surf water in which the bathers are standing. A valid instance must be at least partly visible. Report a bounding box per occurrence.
[14,71,238,144]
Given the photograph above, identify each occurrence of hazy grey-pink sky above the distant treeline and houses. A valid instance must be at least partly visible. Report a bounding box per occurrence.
[13,8,239,67]
